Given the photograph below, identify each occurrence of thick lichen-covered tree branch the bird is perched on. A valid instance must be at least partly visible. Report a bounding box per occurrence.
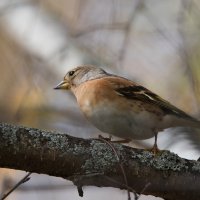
[0,123,200,200]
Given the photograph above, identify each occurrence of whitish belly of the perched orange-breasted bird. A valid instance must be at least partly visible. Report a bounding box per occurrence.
[82,101,155,140]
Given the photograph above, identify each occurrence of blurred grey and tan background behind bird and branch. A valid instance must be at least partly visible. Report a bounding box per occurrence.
[0,0,200,200]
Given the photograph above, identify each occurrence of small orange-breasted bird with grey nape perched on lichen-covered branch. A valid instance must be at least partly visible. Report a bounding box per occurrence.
[54,65,200,153]
